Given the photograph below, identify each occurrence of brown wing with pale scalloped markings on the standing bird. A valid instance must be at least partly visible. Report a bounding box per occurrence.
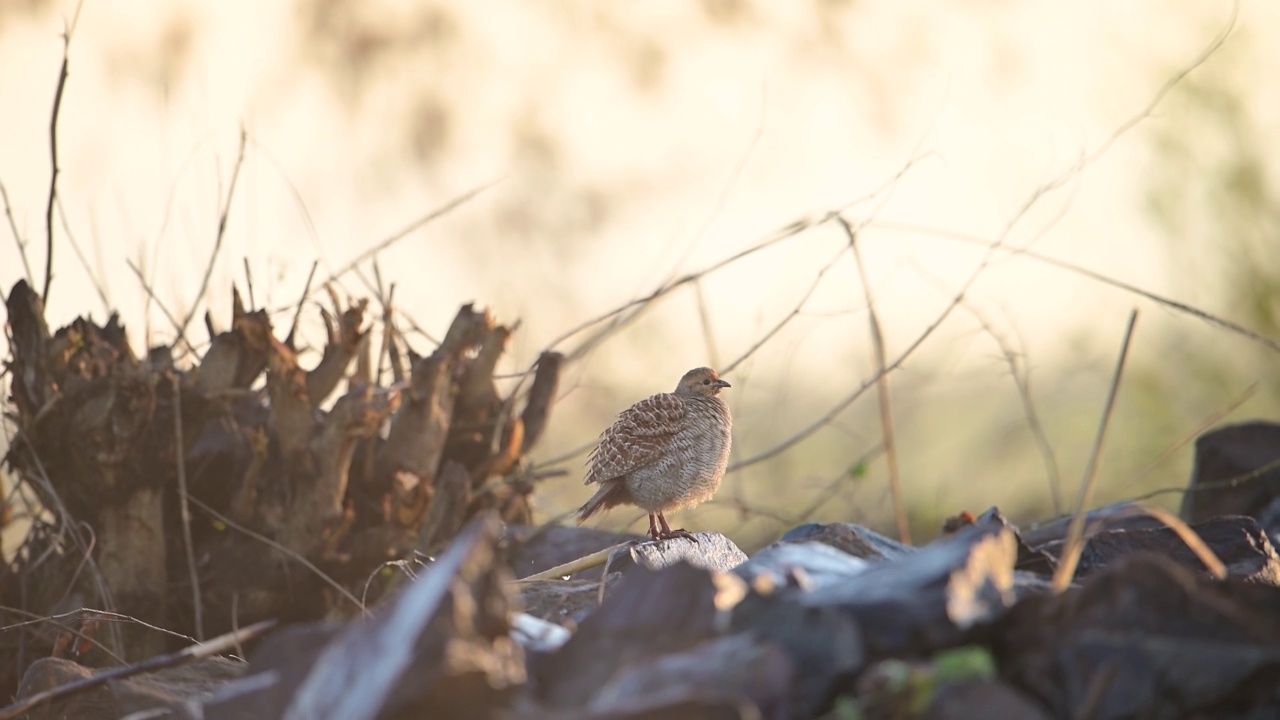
[582,392,685,486]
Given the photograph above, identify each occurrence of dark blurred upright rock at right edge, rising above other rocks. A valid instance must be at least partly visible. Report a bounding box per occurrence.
[1181,421,1280,523]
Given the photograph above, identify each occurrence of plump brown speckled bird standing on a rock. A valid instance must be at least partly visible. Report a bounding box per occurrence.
[577,368,733,542]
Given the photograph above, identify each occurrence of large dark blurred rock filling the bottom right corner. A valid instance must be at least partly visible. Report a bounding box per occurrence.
[993,553,1280,720]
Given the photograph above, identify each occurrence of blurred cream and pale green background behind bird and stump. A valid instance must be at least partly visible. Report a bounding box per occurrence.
[0,0,1280,550]
